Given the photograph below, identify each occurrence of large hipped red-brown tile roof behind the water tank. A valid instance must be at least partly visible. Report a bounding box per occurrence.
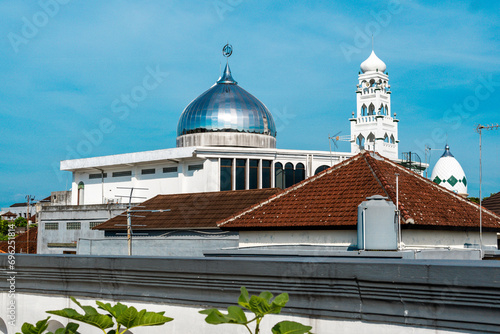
[218,152,500,231]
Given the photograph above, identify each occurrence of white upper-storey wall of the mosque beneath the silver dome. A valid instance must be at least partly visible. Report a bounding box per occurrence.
[61,147,353,205]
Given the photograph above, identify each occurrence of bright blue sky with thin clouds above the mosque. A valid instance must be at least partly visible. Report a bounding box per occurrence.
[0,0,500,207]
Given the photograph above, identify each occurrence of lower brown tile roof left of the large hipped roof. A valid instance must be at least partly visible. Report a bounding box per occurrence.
[94,188,282,231]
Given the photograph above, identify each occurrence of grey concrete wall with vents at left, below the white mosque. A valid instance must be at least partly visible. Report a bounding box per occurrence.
[37,204,126,254]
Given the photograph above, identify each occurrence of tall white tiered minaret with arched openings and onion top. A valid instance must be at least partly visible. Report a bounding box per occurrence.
[350,51,399,159]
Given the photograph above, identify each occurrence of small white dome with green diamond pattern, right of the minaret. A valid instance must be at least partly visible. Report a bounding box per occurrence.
[431,145,467,194]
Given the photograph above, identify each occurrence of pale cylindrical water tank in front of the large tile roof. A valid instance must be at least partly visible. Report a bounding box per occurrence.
[358,195,398,250]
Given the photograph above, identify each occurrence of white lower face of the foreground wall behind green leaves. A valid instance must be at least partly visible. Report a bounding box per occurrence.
[0,291,463,334]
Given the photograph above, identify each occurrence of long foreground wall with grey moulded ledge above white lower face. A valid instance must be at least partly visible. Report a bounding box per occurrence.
[0,255,500,334]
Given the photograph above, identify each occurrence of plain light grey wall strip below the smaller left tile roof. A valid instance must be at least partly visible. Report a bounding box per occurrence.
[77,235,238,257]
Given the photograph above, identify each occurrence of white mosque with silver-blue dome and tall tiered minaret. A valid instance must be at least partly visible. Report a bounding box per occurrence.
[61,45,399,205]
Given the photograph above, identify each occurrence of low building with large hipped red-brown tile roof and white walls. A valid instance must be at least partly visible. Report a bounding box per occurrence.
[218,152,500,256]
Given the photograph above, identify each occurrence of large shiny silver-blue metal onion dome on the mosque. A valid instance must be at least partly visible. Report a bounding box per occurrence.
[177,64,276,142]
